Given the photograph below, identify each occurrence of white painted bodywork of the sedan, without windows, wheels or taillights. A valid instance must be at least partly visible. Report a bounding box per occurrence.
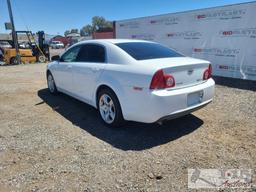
[47,40,215,123]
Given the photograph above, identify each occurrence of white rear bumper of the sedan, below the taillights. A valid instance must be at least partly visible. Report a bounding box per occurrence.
[121,79,215,123]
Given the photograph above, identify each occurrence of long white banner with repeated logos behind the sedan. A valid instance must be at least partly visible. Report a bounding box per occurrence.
[116,2,256,80]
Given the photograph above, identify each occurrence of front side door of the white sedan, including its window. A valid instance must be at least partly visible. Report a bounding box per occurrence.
[55,45,81,93]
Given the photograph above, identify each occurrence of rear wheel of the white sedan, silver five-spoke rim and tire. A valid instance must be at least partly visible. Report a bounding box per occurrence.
[97,88,124,127]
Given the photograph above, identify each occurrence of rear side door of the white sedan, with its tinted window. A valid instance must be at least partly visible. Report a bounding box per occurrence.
[72,44,106,103]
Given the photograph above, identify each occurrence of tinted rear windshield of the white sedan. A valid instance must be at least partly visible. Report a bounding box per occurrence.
[116,42,184,60]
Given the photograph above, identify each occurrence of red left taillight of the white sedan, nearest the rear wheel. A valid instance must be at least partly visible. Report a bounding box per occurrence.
[150,69,175,89]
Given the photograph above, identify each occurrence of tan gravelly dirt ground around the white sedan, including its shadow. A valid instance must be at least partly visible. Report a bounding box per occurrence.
[0,64,256,191]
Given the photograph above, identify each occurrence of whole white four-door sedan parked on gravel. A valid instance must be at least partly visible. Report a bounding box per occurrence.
[47,39,215,126]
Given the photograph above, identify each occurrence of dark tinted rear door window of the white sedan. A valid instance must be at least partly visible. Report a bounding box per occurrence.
[76,44,106,63]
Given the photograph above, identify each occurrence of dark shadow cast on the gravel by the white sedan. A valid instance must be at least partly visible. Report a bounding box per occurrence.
[36,89,203,151]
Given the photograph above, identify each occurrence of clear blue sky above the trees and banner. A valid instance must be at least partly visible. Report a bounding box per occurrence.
[0,0,252,35]
